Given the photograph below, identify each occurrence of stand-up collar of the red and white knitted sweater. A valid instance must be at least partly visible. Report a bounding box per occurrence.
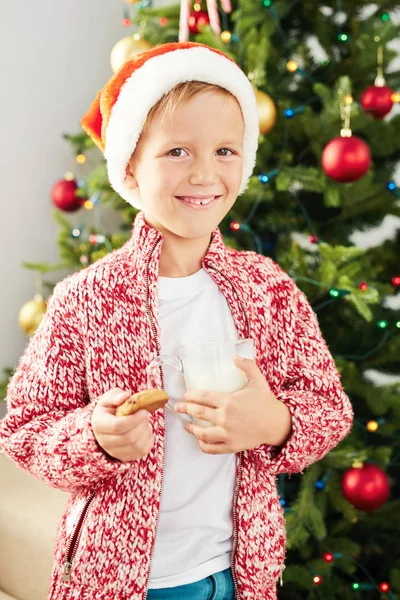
[125,211,228,273]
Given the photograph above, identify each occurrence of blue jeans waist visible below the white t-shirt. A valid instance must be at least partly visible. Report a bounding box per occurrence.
[147,568,235,600]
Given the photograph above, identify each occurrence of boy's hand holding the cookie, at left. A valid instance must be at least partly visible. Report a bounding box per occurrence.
[91,388,154,462]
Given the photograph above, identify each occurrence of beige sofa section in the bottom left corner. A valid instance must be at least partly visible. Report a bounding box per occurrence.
[0,451,68,600]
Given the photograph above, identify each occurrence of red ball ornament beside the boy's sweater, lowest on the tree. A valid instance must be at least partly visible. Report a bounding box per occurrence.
[342,463,390,512]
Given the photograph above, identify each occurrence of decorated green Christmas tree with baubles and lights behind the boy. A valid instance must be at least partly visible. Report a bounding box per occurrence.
[3,0,400,600]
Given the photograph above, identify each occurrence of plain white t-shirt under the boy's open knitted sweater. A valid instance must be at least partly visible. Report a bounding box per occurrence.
[149,269,238,589]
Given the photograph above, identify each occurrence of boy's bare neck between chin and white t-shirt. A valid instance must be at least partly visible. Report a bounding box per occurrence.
[158,231,211,277]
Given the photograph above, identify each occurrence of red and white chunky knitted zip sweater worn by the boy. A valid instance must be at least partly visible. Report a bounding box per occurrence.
[0,213,353,600]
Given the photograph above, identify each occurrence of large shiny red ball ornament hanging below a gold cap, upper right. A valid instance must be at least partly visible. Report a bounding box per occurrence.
[322,135,371,183]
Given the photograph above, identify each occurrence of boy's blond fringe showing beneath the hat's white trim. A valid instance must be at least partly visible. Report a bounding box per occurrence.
[142,81,236,133]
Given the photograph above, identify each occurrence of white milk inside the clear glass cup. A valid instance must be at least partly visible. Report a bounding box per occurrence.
[183,359,247,427]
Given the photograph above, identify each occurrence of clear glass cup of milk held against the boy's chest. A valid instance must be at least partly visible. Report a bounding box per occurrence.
[148,339,254,427]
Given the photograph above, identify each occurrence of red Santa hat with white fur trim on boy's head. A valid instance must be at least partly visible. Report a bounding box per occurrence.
[81,42,259,210]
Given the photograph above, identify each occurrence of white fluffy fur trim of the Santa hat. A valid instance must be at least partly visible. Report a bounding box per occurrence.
[104,48,259,210]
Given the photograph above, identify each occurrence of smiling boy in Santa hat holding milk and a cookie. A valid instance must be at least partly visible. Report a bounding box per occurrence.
[0,43,353,600]
